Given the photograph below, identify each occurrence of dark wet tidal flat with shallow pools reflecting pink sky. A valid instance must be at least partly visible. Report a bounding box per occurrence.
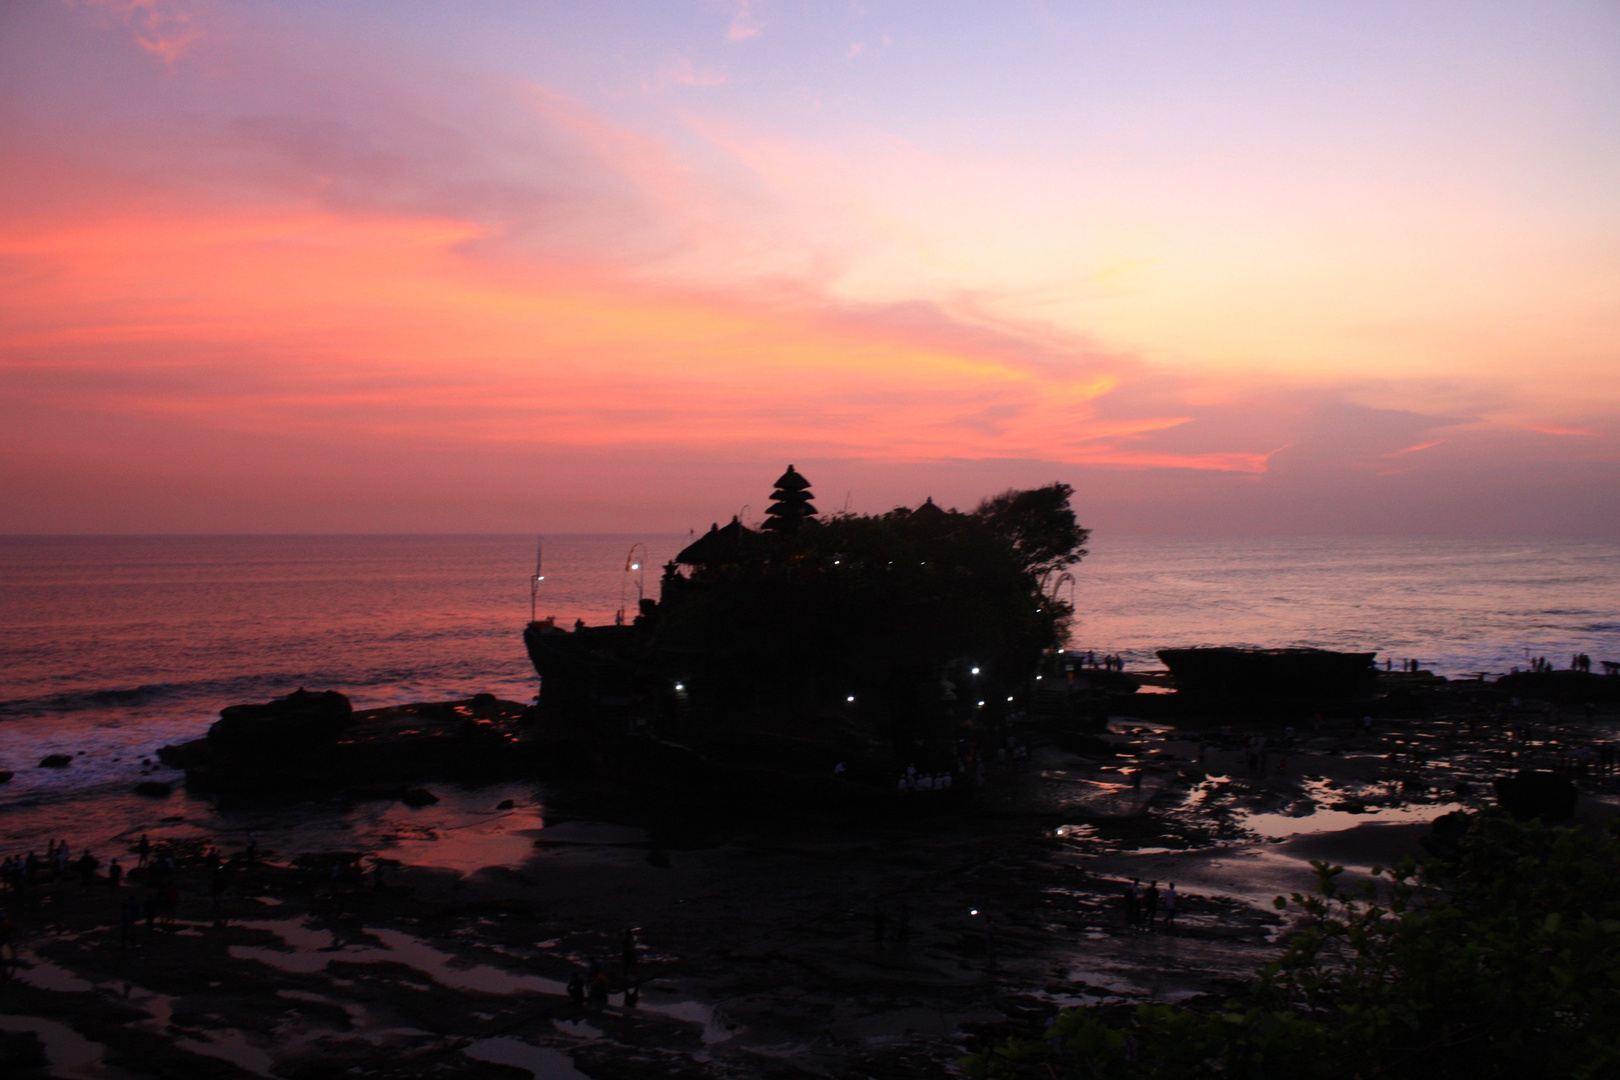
[0,689,1620,1080]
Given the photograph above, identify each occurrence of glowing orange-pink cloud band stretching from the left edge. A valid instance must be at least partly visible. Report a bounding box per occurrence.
[0,198,1205,468]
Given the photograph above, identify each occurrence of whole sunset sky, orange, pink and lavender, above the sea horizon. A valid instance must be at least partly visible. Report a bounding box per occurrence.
[0,0,1620,538]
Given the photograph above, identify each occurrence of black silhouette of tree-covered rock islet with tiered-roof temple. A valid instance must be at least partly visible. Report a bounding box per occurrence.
[523,465,1085,803]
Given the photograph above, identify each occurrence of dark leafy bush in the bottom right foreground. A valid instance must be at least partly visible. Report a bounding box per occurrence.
[962,811,1620,1080]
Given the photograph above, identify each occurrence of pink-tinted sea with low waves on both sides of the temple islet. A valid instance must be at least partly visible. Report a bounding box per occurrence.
[0,536,1620,819]
